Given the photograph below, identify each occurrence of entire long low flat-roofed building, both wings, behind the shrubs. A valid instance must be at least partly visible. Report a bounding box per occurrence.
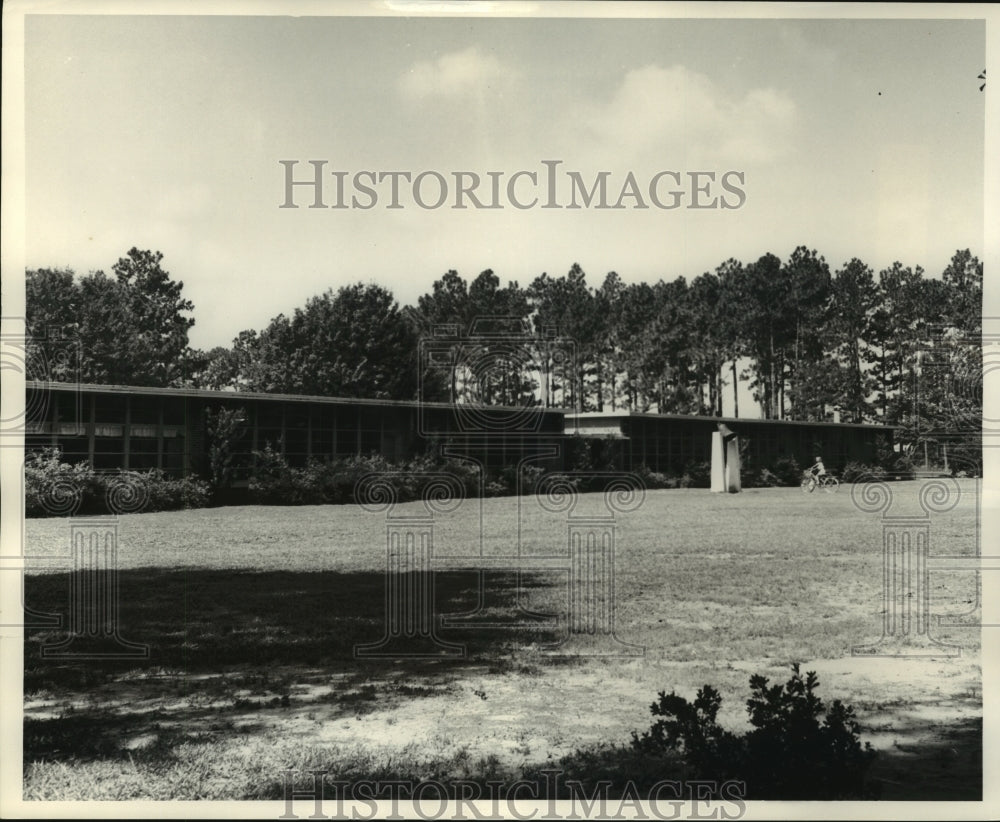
[25,381,893,485]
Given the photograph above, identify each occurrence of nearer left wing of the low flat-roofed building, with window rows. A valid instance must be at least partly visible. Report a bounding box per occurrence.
[25,381,564,484]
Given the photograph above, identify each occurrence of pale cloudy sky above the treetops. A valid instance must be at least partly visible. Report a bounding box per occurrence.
[25,9,985,347]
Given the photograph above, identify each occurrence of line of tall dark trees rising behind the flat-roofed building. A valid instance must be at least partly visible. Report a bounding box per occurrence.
[26,246,983,466]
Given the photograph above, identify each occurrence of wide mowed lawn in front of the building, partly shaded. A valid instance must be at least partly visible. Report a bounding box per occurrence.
[24,480,982,799]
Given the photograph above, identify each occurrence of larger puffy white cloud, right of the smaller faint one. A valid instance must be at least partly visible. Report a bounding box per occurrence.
[577,65,796,164]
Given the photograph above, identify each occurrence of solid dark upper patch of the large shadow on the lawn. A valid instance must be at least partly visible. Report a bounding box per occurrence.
[25,569,565,693]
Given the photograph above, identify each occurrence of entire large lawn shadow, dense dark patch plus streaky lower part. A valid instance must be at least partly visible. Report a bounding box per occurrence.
[24,569,576,762]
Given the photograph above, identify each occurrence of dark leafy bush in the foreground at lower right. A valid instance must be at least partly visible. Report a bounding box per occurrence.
[632,664,875,800]
